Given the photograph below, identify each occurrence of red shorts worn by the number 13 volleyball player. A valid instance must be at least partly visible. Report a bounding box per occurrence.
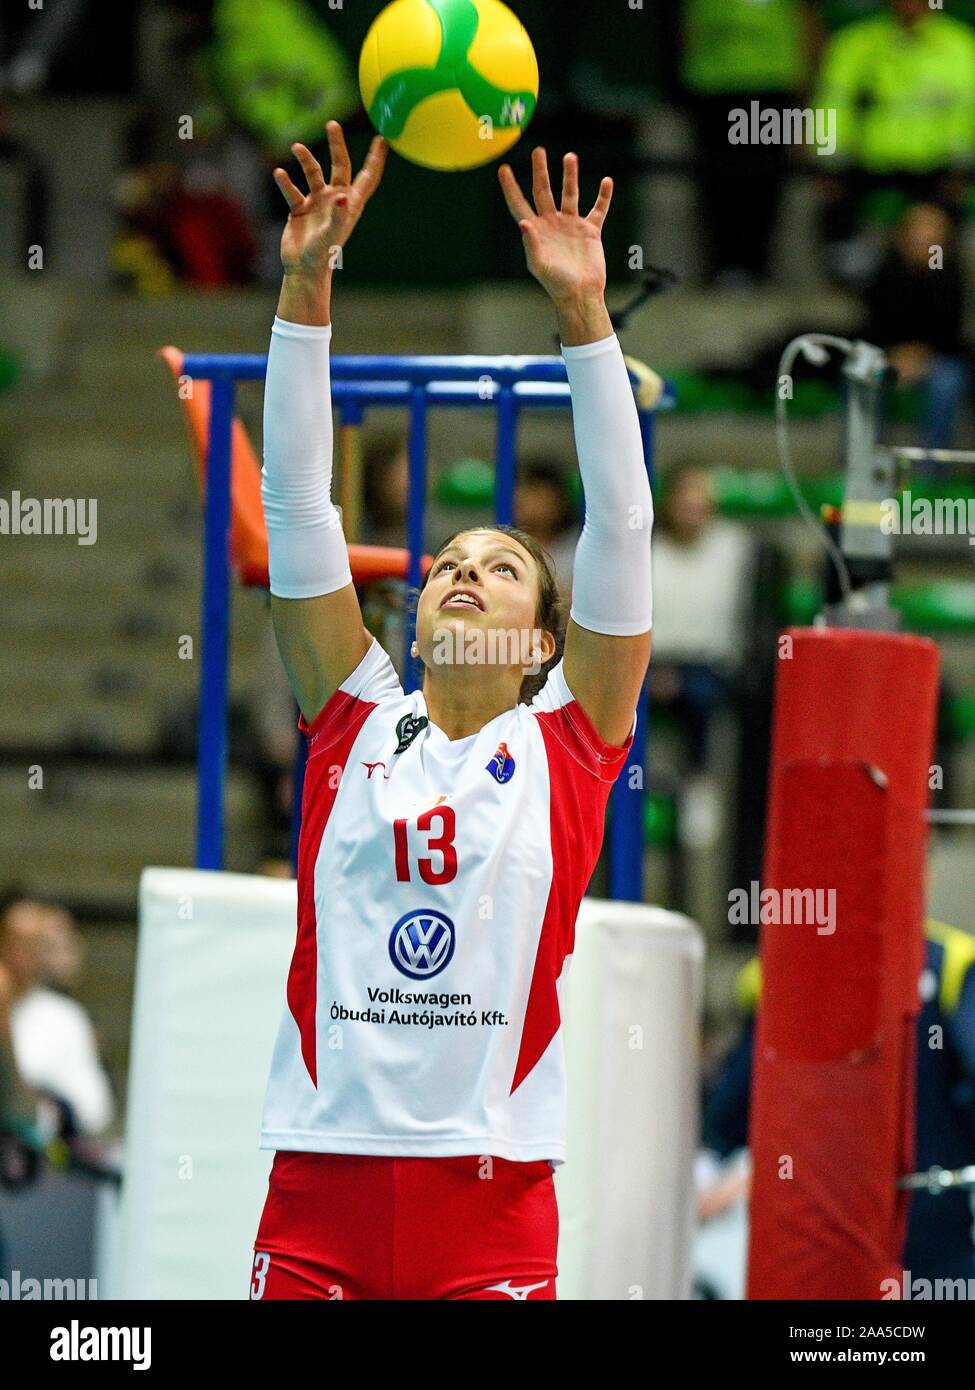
[250,1150,559,1300]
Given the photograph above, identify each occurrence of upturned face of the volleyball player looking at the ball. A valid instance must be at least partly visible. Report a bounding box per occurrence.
[416,531,538,678]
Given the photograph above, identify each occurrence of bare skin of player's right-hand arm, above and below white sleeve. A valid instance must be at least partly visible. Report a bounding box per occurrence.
[498,149,651,745]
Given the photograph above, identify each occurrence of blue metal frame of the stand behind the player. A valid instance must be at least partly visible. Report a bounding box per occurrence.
[182,353,670,901]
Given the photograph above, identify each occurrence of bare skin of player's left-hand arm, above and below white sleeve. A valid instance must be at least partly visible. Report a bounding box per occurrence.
[271,121,388,721]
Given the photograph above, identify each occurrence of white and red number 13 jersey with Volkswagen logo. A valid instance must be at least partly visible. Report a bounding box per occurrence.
[260,641,636,1165]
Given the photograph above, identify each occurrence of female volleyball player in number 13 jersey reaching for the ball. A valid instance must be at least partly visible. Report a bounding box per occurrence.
[250,122,652,1298]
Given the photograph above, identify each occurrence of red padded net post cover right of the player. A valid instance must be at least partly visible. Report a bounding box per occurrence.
[748,628,939,1300]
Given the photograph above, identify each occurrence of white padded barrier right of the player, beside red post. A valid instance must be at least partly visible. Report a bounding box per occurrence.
[555,898,704,1300]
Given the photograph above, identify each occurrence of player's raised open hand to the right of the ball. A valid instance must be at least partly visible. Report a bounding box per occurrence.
[498,146,613,304]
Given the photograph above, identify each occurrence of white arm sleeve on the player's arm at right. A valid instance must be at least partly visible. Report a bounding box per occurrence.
[562,334,654,637]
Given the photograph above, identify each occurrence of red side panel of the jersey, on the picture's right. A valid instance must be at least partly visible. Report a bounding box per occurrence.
[512,701,633,1093]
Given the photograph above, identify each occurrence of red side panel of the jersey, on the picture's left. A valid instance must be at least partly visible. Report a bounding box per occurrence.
[288,691,376,1087]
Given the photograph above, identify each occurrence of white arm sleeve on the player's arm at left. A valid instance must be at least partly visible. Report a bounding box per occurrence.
[260,314,352,599]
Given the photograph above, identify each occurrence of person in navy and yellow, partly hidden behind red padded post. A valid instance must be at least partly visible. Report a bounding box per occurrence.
[702,919,975,1287]
